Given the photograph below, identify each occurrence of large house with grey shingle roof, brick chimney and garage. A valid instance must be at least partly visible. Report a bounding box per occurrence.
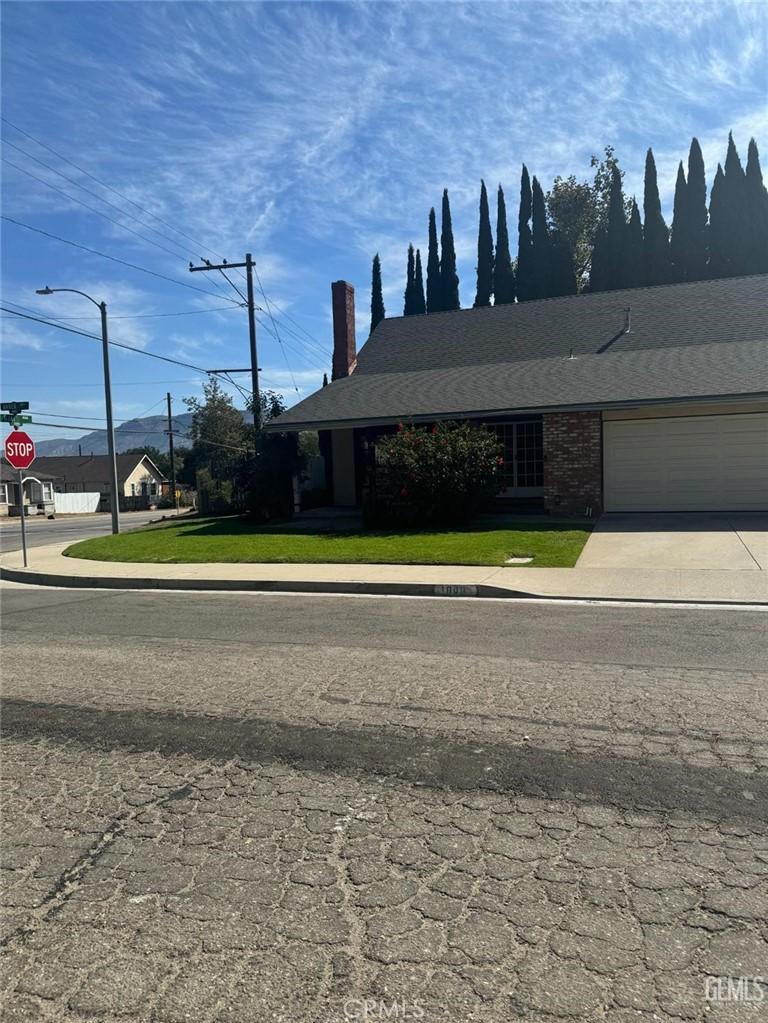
[267,275,768,515]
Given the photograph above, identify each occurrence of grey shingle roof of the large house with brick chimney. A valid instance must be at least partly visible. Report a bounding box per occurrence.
[270,275,768,430]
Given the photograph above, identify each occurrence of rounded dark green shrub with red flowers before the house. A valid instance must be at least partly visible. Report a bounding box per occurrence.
[367,422,503,526]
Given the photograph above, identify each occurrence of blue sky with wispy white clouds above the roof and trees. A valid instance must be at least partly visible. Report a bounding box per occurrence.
[0,0,768,439]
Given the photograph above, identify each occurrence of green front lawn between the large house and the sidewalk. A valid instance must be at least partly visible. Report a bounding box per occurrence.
[64,519,591,568]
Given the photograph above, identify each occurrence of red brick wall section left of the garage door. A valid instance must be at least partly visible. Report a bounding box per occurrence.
[543,412,602,515]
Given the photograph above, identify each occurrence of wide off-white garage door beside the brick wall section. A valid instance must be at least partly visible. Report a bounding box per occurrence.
[603,412,768,512]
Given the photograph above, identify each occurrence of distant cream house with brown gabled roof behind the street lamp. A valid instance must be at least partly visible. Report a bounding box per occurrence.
[34,454,168,512]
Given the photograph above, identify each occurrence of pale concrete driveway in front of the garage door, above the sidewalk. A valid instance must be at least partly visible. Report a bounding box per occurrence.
[577,512,768,572]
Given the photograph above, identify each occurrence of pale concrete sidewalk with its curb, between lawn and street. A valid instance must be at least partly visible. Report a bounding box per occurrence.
[0,543,768,604]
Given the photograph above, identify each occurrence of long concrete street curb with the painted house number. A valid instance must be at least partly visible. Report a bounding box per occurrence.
[0,566,768,608]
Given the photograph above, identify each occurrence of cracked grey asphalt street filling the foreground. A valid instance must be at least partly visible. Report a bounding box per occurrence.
[1,585,768,1023]
